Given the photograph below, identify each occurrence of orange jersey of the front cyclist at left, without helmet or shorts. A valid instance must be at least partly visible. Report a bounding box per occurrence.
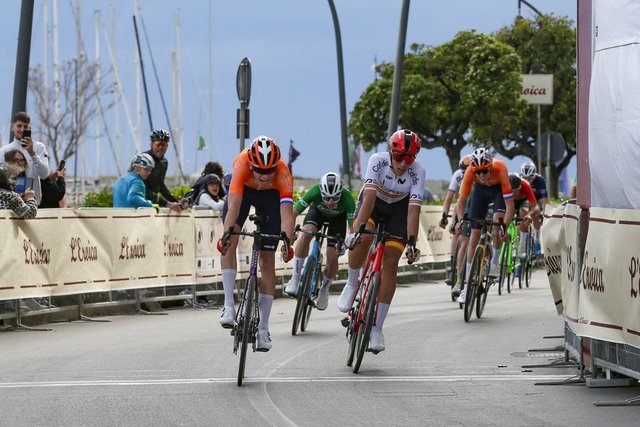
[229,150,293,204]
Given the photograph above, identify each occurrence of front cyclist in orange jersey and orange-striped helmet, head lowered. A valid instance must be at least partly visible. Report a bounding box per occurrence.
[218,135,294,351]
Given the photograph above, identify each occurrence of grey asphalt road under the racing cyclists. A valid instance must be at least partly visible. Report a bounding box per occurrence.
[0,270,640,426]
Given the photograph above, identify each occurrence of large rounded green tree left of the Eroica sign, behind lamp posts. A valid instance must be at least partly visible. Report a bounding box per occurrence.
[349,31,524,171]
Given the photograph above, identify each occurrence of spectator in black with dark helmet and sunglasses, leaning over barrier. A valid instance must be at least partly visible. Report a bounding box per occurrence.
[145,129,182,212]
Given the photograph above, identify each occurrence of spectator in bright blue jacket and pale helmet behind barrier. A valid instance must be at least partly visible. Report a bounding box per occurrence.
[112,153,157,208]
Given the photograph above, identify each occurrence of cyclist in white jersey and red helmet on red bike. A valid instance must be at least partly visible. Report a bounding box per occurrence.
[338,129,425,353]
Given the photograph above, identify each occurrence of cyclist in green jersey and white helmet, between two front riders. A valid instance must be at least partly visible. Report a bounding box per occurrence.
[285,172,356,310]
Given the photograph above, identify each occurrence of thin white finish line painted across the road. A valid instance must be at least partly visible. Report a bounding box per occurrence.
[0,374,575,388]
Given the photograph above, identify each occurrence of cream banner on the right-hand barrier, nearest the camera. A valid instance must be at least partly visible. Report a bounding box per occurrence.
[566,207,640,348]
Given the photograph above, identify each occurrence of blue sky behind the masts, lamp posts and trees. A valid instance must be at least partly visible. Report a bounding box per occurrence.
[0,0,577,187]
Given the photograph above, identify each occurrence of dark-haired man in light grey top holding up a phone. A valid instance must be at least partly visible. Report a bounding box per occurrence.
[0,111,49,203]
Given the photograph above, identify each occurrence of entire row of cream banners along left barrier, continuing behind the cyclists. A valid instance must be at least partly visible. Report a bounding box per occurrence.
[0,206,451,300]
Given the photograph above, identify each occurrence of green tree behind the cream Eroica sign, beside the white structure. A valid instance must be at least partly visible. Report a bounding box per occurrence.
[494,15,576,197]
